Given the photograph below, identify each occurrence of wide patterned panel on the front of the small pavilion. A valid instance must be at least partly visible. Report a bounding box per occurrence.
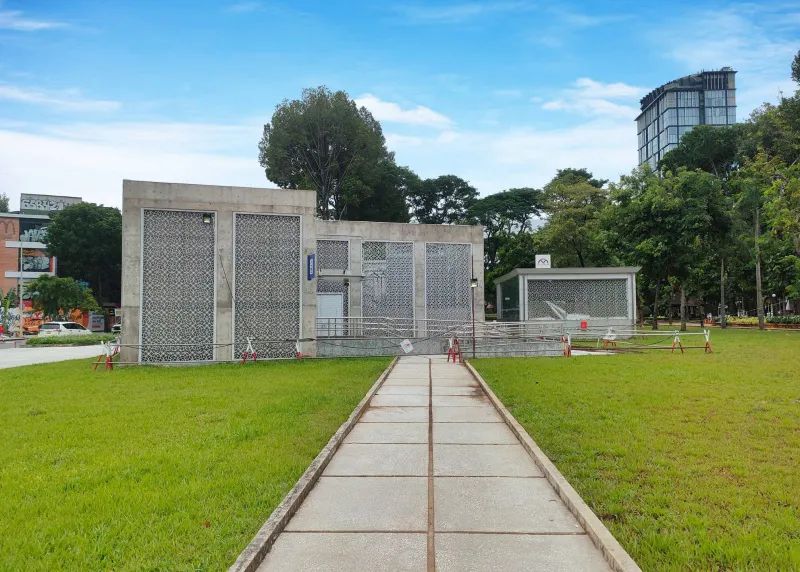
[528,278,631,320]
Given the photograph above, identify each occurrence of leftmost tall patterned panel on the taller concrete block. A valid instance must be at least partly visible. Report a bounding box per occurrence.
[141,210,216,362]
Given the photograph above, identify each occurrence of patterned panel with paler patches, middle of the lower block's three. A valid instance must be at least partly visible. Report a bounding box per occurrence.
[361,241,414,320]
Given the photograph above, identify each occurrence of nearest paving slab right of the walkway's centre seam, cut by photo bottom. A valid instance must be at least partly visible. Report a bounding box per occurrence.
[435,532,609,572]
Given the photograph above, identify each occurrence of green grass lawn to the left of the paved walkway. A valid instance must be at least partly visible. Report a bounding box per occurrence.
[0,358,389,570]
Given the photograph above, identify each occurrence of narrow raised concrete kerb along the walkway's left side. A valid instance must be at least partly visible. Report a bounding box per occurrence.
[228,358,399,572]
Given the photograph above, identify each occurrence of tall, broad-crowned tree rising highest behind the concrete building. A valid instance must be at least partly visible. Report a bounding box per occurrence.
[258,86,388,220]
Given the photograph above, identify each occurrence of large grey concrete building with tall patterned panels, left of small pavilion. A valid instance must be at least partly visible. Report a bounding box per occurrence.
[122,181,484,363]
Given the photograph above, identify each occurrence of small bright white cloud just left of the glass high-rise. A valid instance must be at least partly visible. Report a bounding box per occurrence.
[531,77,646,121]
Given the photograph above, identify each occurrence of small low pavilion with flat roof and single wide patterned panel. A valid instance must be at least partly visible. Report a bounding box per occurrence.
[494,266,640,329]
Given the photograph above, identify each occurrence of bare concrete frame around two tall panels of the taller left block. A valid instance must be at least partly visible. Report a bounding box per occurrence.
[121,180,316,361]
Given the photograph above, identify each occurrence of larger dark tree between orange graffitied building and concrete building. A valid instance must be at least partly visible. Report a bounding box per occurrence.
[47,203,122,301]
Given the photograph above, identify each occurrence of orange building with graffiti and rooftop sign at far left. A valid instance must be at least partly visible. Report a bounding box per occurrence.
[0,194,81,299]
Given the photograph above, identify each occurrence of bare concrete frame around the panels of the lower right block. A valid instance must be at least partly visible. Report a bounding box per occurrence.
[317,220,485,322]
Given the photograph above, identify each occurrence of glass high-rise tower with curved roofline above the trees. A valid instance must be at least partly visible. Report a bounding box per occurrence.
[636,67,736,169]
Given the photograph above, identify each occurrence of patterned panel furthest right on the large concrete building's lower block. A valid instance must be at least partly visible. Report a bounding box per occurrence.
[425,243,472,323]
